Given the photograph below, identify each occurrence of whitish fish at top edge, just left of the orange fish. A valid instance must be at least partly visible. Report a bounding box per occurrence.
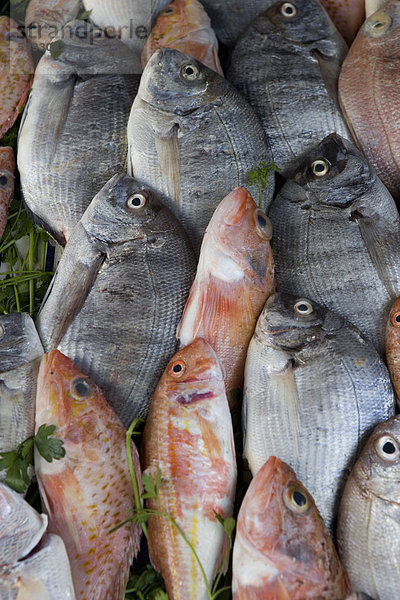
[83,0,171,55]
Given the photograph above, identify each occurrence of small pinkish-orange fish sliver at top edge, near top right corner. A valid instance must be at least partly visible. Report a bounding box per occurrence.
[320,0,365,46]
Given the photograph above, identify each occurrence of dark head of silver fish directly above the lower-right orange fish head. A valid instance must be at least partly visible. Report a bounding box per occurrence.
[256,293,343,352]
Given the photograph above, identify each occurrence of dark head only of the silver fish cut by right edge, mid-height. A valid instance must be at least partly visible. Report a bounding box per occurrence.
[293,133,376,209]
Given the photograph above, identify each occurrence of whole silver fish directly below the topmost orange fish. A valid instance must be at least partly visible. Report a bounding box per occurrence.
[128,48,274,255]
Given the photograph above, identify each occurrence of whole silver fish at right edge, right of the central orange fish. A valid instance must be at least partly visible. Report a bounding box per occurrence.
[269,134,400,355]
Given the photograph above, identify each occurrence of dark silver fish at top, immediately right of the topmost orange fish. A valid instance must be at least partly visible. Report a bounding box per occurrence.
[227,0,350,178]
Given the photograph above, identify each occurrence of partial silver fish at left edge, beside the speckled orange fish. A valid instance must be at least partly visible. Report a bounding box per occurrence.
[0,313,44,478]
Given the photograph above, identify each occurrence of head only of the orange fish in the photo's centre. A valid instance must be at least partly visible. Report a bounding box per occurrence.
[199,187,272,287]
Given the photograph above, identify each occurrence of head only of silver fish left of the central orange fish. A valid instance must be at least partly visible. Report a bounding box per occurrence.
[81,174,176,246]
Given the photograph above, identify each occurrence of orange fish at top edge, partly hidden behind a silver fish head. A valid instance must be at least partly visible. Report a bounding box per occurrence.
[142,0,224,76]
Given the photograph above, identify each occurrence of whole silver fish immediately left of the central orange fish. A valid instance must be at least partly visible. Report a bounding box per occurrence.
[37,175,195,427]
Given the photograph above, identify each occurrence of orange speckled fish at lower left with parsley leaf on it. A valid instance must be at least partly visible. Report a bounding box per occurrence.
[35,350,141,600]
